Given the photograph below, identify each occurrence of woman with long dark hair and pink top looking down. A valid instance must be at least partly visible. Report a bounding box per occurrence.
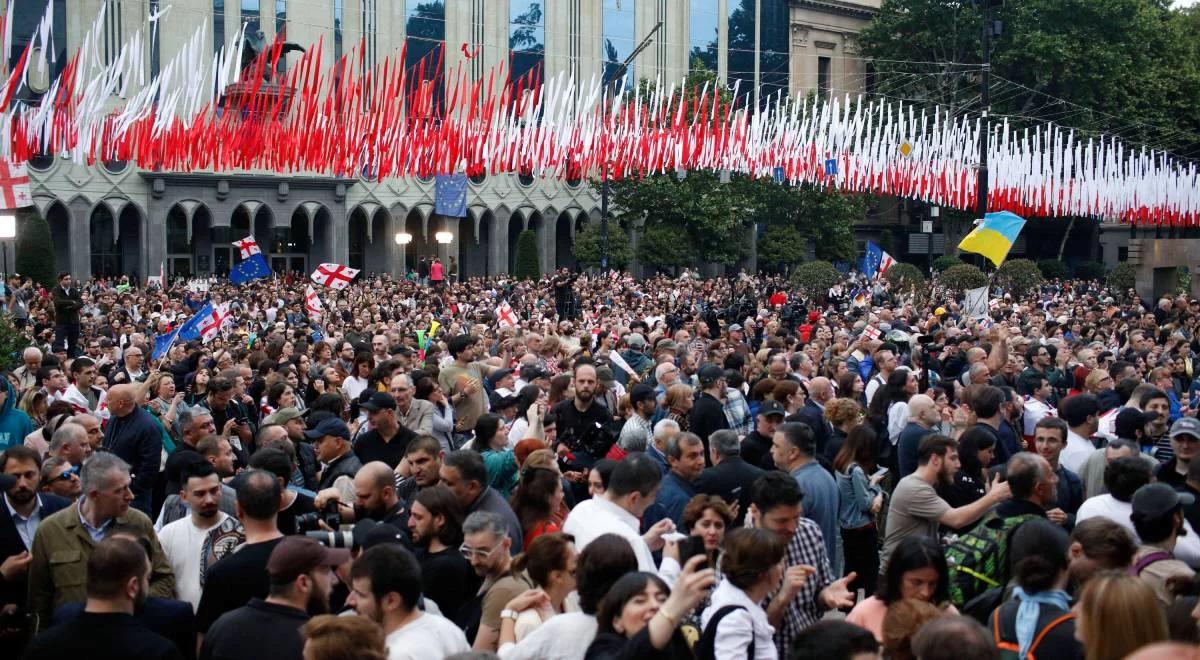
[846,536,959,643]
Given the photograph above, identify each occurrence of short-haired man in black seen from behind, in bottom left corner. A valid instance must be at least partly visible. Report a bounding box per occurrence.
[24,535,180,660]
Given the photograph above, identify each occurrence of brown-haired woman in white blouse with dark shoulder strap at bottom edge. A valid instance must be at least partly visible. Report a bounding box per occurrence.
[698,528,786,660]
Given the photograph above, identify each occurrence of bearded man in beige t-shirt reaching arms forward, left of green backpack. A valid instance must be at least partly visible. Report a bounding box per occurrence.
[881,433,1009,569]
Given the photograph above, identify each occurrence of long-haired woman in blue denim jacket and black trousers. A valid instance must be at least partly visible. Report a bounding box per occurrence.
[827,427,883,602]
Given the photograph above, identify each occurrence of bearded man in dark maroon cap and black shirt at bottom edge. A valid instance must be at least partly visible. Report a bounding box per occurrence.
[200,536,350,660]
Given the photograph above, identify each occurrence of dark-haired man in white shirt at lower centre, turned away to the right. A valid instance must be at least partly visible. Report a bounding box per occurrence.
[563,451,674,572]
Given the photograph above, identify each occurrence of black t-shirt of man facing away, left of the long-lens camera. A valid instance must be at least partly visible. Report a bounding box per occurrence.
[196,536,283,632]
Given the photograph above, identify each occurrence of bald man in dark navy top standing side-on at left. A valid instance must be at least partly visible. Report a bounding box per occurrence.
[104,385,162,516]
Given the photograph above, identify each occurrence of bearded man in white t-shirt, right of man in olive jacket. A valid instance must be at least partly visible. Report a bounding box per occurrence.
[158,461,229,610]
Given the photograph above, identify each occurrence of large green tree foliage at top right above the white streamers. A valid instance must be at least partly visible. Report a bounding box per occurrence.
[859,0,1200,152]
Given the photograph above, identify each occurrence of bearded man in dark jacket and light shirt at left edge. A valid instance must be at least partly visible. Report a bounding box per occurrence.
[0,445,70,648]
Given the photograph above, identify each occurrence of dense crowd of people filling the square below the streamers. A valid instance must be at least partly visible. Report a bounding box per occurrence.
[0,270,1200,660]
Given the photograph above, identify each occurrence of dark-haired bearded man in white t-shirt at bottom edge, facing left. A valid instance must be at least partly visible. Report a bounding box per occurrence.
[346,544,470,660]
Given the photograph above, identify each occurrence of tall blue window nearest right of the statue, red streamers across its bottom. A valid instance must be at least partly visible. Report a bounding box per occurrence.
[404,0,446,116]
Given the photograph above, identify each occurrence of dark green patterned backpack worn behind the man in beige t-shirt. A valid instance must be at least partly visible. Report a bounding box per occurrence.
[946,512,1037,607]
